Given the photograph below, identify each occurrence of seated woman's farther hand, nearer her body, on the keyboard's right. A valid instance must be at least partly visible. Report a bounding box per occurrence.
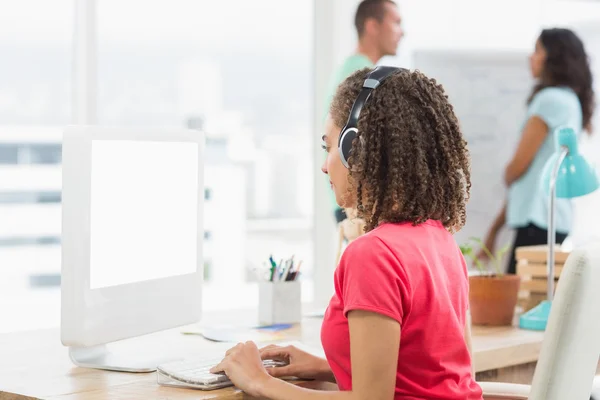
[260,345,335,383]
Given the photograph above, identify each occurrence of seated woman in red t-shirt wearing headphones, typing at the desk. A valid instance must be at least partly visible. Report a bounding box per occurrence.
[212,67,482,400]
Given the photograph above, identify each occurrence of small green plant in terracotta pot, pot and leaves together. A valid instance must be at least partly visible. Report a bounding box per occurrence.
[460,238,521,326]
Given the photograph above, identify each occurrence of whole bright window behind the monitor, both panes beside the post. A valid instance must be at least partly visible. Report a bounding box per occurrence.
[0,0,313,332]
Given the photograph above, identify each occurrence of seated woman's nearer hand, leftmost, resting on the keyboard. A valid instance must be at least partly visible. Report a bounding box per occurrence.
[210,342,272,397]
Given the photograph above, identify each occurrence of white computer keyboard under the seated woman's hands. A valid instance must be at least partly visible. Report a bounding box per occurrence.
[156,358,287,390]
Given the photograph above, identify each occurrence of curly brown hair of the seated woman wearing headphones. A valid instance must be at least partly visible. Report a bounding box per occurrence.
[330,68,471,232]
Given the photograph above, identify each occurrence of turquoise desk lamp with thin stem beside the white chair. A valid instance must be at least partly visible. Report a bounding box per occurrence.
[519,127,600,331]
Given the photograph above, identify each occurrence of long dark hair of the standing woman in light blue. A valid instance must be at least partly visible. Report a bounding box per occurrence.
[528,28,595,133]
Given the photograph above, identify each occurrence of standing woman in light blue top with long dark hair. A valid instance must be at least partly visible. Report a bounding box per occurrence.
[479,28,594,274]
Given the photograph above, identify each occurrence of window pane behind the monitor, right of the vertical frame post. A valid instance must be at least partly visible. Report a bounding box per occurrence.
[98,0,313,310]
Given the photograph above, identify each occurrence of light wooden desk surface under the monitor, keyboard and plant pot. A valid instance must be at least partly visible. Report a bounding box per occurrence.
[0,311,543,400]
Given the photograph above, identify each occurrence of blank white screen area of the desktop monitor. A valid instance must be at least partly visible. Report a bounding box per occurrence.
[90,140,199,289]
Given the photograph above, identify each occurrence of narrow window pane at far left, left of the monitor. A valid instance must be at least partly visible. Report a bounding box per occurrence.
[0,0,73,332]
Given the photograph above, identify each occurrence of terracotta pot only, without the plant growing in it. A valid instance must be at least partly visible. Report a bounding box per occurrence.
[469,275,521,326]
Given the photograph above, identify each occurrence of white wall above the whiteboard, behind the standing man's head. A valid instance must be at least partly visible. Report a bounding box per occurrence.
[332,0,600,67]
